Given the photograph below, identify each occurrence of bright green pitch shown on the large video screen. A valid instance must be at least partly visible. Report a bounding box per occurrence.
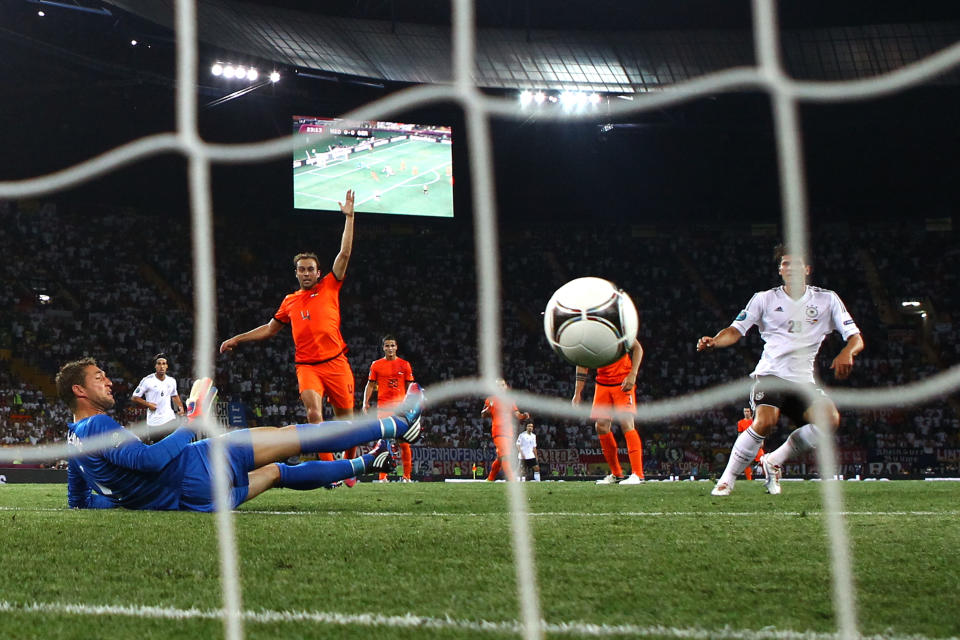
[293,140,453,217]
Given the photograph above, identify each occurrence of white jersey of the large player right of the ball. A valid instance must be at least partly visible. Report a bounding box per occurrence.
[731,286,860,383]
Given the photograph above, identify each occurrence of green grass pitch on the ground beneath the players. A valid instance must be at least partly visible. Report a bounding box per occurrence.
[0,481,960,639]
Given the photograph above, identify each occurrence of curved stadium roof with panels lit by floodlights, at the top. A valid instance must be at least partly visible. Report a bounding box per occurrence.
[107,0,960,94]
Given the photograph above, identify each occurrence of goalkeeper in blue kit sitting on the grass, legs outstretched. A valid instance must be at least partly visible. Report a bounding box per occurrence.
[57,358,423,511]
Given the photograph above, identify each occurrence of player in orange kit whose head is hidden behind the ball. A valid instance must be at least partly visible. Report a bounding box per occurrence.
[573,341,643,484]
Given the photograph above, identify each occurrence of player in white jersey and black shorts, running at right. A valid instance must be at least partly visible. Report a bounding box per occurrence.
[697,246,863,496]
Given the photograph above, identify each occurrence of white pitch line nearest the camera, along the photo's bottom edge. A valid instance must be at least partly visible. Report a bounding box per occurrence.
[0,601,944,640]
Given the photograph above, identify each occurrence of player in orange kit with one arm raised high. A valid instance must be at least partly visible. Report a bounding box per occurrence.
[220,189,354,472]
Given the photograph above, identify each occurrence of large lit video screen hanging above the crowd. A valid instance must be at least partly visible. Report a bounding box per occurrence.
[293,116,453,218]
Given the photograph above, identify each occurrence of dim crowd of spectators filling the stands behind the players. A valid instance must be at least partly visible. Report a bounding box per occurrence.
[0,202,960,476]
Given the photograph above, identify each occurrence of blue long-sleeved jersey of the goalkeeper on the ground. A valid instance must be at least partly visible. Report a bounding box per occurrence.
[67,414,194,510]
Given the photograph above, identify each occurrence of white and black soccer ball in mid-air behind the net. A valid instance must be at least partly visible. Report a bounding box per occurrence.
[543,278,639,369]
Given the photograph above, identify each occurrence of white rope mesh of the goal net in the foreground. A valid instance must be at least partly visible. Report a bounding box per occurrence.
[0,0,960,640]
